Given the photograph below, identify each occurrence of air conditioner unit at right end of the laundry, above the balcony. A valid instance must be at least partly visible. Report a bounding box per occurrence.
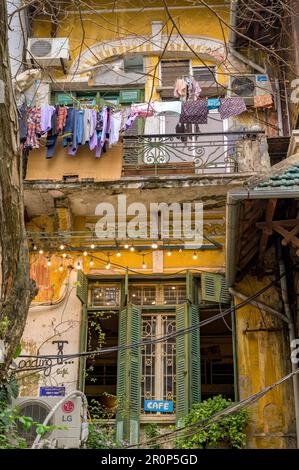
[228,74,273,104]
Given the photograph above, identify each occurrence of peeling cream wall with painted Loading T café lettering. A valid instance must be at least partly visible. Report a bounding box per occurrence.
[17,270,81,397]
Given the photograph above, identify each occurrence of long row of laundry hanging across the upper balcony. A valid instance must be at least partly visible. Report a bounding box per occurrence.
[20,98,252,159]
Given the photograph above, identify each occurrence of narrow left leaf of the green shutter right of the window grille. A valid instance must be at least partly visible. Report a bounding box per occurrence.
[176,303,190,427]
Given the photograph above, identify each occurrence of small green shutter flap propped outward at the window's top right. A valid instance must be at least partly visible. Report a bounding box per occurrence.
[201,273,231,304]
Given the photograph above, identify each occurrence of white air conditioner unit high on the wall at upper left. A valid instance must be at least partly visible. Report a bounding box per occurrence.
[26,38,70,67]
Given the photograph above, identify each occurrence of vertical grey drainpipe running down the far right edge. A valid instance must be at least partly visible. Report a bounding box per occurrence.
[277,246,299,449]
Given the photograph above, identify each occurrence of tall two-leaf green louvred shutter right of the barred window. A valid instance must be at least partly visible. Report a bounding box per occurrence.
[176,302,200,427]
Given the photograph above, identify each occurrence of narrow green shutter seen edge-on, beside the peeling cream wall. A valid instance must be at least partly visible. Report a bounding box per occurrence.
[76,269,88,392]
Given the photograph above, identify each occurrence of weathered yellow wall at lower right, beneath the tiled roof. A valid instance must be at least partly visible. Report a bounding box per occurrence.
[235,276,296,449]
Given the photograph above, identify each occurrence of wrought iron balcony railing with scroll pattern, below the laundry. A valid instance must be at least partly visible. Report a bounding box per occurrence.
[123,131,267,175]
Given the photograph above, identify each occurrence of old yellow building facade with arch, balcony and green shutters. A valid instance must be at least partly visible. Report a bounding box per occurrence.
[15,0,294,448]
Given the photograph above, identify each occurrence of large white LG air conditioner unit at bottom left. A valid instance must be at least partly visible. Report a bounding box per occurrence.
[13,397,82,448]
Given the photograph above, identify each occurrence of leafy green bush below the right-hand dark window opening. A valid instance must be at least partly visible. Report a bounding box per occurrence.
[176,395,249,449]
